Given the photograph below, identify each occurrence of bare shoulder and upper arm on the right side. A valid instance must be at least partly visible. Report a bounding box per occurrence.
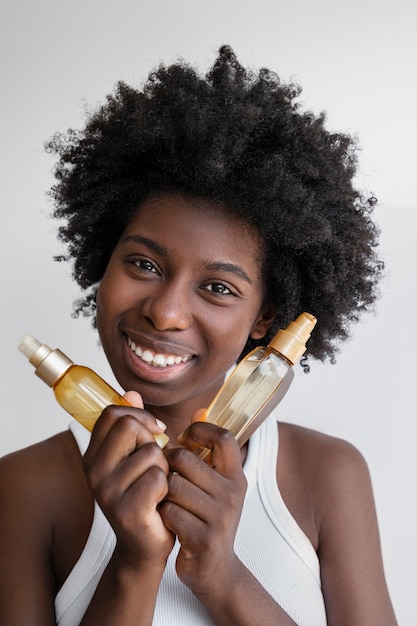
[277,423,396,626]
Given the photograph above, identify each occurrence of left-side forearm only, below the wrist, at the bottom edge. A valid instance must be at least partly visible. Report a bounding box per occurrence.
[80,553,164,626]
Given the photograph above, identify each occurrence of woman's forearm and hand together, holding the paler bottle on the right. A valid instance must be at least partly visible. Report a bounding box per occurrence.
[161,423,294,626]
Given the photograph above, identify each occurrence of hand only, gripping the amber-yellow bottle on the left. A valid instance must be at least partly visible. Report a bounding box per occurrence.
[84,392,174,568]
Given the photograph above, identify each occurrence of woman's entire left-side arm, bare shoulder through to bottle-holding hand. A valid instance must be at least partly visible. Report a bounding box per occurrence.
[0,398,173,626]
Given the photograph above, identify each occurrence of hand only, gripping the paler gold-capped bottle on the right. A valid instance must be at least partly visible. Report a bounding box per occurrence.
[160,422,246,596]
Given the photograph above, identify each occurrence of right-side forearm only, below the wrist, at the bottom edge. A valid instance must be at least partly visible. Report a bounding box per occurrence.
[196,561,295,626]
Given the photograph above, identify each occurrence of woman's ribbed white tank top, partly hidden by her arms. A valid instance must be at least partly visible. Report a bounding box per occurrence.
[55,414,327,626]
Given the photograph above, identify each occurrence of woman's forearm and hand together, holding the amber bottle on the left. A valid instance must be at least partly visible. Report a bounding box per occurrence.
[81,398,174,626]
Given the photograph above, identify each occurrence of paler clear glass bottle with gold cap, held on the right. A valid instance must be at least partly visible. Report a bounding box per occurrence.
[193,313,317,459]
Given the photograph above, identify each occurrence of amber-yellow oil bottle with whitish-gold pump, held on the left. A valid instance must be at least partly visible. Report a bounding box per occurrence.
[19,335,168,448]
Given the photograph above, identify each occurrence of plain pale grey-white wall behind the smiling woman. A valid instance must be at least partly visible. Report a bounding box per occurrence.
[0,0,417,626]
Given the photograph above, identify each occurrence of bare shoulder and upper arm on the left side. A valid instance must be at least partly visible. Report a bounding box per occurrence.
[0,432,89,626]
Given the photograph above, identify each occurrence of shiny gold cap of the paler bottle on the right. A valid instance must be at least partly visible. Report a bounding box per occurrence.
[268,313,317,365]
